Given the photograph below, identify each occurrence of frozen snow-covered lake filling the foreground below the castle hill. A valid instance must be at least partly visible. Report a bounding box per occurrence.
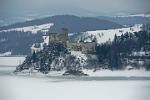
[0,66,150,100]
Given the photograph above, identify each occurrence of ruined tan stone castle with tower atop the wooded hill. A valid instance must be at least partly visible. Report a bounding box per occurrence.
[31,28,96,54]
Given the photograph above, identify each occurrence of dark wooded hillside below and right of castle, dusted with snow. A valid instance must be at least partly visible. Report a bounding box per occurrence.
[15,25,150,76]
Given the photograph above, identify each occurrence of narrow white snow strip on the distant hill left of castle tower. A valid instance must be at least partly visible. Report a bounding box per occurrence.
[0,23,54,34]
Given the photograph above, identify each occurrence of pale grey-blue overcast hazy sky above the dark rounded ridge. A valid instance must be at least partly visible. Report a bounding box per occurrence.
[0,0,150,16]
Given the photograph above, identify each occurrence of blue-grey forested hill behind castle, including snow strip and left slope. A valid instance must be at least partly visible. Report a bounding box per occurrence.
[0,15,123,54]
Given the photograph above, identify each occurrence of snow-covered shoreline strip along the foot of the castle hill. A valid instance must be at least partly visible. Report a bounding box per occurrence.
[0,66,150,80]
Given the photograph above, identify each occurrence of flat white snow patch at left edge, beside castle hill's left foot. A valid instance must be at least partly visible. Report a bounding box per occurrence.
[0,56,25,66]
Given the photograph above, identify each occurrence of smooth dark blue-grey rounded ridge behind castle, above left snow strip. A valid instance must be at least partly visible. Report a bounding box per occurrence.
[0,15,123,32]
